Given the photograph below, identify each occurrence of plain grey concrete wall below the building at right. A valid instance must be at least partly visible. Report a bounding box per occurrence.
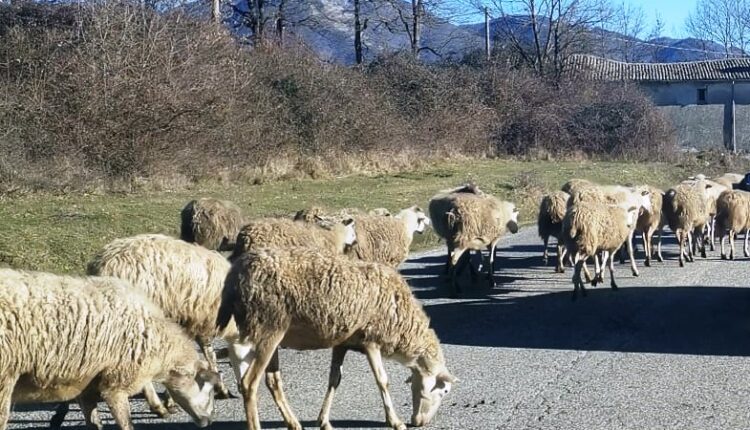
[657,105,750,151]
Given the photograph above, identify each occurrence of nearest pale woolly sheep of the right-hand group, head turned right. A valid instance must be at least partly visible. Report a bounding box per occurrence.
[562,201,638,299]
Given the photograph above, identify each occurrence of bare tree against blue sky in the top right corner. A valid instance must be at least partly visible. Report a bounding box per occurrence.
[685,0,750,58]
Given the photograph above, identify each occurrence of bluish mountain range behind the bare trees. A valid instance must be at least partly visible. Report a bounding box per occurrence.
[201,0,741,64]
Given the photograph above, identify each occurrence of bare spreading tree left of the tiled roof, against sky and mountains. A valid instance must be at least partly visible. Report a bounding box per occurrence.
[469,0,611,77]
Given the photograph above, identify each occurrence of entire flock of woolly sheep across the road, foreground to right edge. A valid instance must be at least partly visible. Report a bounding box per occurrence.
[0,174,750,430]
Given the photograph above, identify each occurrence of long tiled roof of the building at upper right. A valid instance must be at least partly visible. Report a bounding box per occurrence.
[566,54,750,82]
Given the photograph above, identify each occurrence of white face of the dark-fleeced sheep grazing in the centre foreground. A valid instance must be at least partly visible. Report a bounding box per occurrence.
[410,369,456,427]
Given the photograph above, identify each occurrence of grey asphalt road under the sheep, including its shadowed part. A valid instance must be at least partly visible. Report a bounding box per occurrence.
[8,229,750,430]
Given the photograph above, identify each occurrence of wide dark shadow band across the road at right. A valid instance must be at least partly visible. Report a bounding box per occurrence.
[425,286,750,356]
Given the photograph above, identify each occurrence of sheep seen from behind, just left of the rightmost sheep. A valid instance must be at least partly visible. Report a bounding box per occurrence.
[662,184,708,267]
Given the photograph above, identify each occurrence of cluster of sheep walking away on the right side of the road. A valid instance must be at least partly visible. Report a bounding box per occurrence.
[538,173,750,299]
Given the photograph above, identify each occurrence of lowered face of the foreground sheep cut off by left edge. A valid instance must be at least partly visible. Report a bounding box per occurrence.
[164,360,219,428]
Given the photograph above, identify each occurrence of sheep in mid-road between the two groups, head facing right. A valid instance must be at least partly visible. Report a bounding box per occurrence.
[429,187,518,293]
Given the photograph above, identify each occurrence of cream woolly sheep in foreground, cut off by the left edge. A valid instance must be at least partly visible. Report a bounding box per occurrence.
[0,269,218,429]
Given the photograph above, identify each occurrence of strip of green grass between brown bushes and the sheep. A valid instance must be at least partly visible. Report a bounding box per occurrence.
[0,160,691,273]
